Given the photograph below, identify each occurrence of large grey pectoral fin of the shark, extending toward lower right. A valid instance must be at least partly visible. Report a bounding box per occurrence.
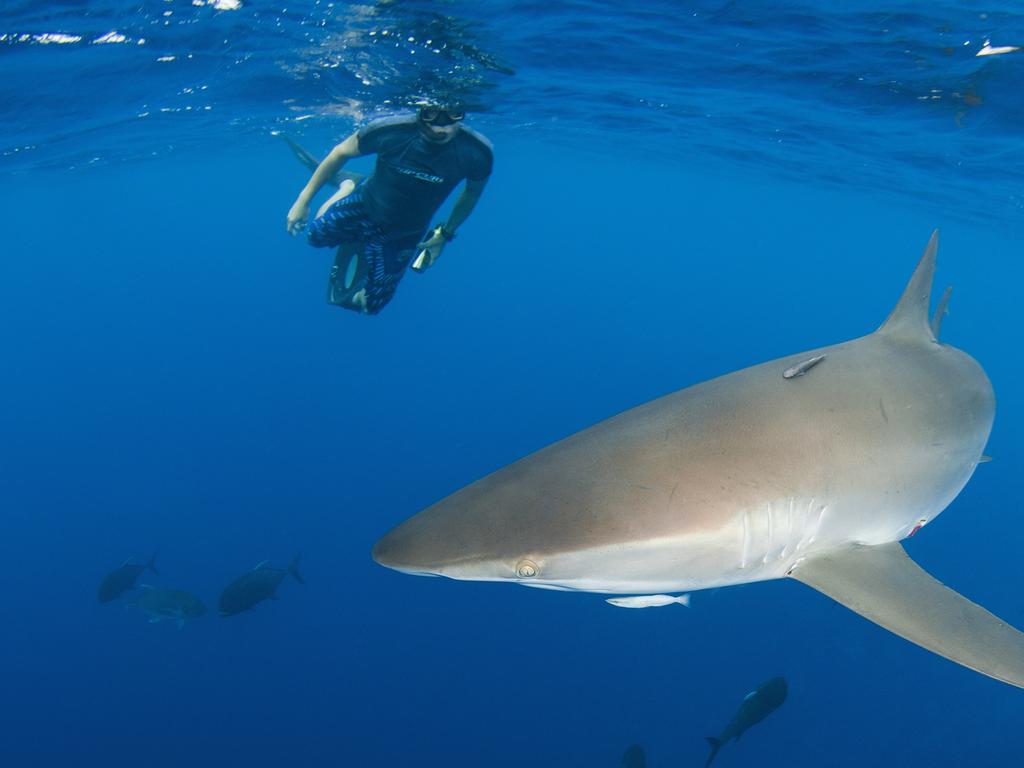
[790,543,1024,687]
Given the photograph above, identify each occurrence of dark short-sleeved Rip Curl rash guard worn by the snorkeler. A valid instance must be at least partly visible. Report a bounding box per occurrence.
[358,116,494,231]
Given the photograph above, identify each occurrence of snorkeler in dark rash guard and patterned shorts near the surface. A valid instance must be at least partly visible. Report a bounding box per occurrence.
[288,104,494,314]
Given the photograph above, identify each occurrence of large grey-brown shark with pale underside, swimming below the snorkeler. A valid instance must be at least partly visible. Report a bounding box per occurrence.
[373,232,1024,686]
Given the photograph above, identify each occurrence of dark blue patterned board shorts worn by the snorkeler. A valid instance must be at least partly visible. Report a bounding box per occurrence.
[308,187,425,314]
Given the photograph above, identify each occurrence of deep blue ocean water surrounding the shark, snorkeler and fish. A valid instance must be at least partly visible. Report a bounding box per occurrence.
[0,0,1024,768]
